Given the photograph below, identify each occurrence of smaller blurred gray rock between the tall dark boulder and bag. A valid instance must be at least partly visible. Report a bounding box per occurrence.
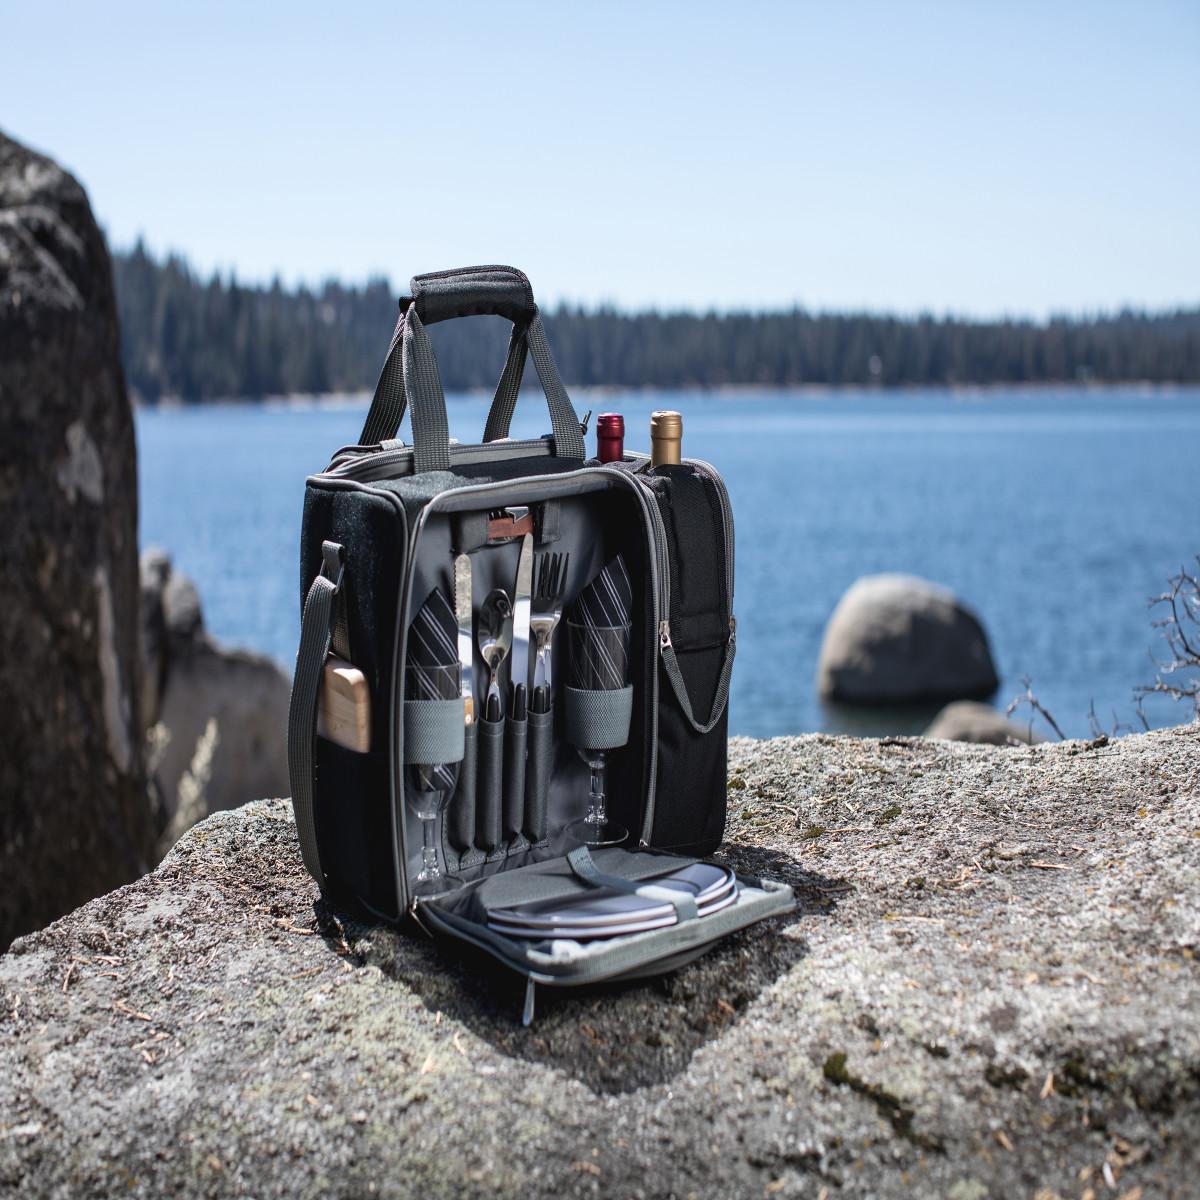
[142,548,292,853]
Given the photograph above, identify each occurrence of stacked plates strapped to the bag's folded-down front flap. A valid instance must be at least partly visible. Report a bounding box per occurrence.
[487,863,738,942]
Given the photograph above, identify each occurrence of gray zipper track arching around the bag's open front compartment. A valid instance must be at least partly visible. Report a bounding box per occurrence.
[392,465,670,912]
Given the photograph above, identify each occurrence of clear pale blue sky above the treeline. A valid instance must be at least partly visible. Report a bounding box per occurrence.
[0,0,1200,316]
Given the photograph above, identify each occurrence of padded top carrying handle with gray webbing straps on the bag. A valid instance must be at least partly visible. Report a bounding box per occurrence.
[359,266,584,472]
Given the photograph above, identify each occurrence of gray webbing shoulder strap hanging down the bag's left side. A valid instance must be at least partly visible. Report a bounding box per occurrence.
[288,541,344,887]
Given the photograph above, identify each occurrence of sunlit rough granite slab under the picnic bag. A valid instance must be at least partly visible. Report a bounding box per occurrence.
[0,724,1200,1200]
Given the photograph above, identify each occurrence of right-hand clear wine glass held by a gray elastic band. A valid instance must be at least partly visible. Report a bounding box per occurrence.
[566,618,632,846]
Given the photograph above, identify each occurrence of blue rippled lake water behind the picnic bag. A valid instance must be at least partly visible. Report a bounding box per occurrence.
[137,389,1200,737]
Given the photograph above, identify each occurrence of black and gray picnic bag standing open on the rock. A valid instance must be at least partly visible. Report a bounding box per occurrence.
[288,266,794,1022]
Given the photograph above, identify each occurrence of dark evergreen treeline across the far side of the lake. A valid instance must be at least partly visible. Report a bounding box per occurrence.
[113,242,1200,402]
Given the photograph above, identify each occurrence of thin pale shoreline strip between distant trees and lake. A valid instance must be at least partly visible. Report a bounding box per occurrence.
[134,379,1200,410]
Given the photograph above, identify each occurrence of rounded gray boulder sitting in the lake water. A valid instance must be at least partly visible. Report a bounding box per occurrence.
[817,575,1000,704]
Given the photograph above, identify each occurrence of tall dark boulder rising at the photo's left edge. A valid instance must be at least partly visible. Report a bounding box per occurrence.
[0,133,154,948]
